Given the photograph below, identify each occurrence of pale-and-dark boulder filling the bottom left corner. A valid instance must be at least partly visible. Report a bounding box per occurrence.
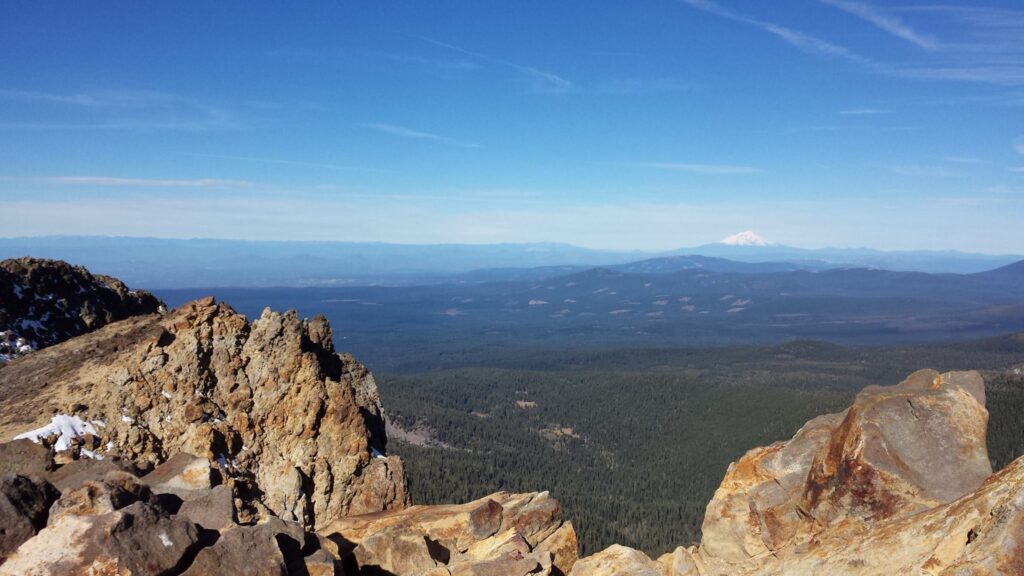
[0,502,200,576]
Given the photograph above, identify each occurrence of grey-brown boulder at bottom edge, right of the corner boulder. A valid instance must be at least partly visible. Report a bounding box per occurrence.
[182,519,305,576]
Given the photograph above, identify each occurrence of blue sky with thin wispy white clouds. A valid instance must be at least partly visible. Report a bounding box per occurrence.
[0,0,1024,253]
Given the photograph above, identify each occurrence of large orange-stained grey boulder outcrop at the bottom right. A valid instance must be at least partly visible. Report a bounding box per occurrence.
[573,370,1024,576]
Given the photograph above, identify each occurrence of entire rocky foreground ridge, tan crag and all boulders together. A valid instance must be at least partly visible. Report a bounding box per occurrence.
[0,258,1024,576]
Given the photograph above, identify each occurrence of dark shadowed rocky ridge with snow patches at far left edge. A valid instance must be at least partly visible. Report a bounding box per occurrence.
[0,258,163,364]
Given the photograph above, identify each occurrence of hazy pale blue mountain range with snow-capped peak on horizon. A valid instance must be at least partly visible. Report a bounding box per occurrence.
[0,231,1024,289]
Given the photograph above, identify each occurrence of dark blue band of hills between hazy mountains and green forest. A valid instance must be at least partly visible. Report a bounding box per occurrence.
[158,258,1024,372]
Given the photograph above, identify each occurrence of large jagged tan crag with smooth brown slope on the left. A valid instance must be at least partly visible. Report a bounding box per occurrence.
[0,298,408,528]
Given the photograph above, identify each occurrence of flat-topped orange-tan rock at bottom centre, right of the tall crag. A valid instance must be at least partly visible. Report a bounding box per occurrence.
[321,492,577,575]
